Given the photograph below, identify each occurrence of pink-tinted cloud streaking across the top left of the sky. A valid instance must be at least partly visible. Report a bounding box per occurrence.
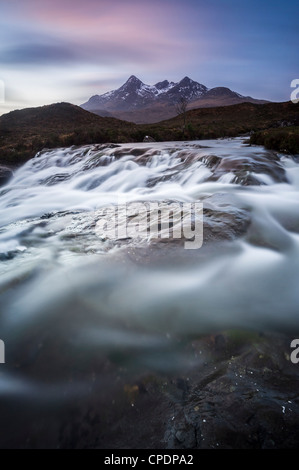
[4,0,197,59]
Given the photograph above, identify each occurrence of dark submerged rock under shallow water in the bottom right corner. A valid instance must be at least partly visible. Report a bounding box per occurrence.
[74,332,299,450]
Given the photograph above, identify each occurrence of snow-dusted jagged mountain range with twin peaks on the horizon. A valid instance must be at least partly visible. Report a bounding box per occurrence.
[81,75,267,124]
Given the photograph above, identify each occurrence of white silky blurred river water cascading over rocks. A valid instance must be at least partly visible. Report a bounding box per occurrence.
[0,139,299,448]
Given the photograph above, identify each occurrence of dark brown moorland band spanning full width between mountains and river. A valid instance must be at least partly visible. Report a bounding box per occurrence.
[0,102,299,165]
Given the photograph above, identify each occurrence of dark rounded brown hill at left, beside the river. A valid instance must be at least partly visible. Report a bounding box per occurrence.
[0,103,132,164]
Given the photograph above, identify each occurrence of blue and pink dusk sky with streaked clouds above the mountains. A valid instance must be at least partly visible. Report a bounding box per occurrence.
[0,0,299,115]
